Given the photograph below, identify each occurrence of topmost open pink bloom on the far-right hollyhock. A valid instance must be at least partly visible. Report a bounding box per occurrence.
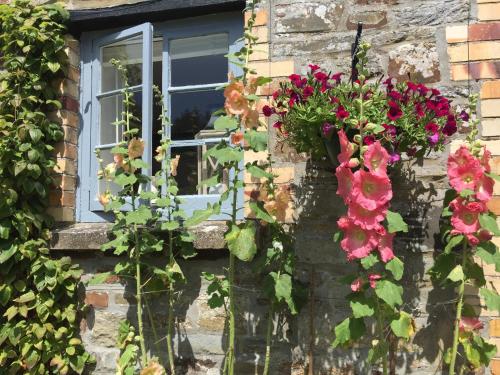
[448,146,483,193]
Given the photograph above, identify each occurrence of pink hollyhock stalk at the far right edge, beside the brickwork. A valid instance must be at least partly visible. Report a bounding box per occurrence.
[429,95,500,375]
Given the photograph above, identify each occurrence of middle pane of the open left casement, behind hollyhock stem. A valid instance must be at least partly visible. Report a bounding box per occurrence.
[99,91,142,145]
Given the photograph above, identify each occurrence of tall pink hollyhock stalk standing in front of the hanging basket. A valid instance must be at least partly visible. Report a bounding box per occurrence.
[333,43,414,375]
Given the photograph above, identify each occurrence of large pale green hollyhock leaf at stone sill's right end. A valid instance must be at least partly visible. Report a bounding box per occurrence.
[224,221,257,262]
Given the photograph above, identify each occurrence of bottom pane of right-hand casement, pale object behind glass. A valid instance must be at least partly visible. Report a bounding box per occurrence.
[172,144,227,195]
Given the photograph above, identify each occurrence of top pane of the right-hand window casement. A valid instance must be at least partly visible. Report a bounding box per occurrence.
[170,34,229,87]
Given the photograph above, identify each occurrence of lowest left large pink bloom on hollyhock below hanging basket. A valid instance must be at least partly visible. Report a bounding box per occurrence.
[337,217,378,260]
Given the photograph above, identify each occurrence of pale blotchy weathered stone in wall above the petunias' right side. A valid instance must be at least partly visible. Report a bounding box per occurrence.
[388,43,441,83]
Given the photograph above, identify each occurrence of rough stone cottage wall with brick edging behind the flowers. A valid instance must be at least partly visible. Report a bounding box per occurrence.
[42,0,500,375]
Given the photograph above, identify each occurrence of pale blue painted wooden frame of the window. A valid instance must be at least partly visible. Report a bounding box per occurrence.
[76,13,244,222]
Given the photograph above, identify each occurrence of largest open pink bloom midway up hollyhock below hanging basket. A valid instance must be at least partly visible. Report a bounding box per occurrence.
[352,169,392,210]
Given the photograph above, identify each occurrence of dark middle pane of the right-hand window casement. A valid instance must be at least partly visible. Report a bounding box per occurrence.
[171,90,224,140]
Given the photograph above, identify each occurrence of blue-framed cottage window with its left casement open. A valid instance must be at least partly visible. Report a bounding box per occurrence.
[77,13,243,222]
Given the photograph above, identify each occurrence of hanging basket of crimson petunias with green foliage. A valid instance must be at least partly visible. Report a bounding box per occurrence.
[264,46,457,162]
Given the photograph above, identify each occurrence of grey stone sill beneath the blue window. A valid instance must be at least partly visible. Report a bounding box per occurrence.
[50,221,227,251]
